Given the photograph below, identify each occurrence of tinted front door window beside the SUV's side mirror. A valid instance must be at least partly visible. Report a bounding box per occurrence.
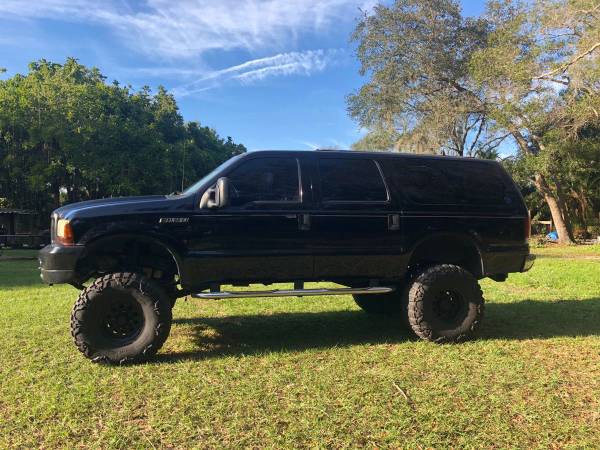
[228,158,300,206]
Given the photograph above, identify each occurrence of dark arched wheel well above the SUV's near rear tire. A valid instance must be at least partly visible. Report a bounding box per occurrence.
[408,235,483,278]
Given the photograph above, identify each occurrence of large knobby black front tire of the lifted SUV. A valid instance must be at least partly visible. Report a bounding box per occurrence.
[71,272,172,364]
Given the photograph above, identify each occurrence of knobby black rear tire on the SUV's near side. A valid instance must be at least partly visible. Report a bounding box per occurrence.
[408,264,484,343]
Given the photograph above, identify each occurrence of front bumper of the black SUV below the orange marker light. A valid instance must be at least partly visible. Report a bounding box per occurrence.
[38,244,85,284]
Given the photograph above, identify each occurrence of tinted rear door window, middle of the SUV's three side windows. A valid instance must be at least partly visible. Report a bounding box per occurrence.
[319,158,387,202]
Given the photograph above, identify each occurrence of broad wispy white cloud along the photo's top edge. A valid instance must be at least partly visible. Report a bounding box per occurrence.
[0,0,373,59]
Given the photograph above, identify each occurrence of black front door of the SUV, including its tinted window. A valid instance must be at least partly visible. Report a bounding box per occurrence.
[186,156,313,285]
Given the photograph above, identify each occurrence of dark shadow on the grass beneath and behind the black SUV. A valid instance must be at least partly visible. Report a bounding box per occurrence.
[157,298,600,363]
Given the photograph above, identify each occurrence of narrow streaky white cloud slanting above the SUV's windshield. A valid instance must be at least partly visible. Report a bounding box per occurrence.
[172,49,343,97]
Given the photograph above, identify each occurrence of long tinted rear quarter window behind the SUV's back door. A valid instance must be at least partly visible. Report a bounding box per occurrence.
[389,161,517,205]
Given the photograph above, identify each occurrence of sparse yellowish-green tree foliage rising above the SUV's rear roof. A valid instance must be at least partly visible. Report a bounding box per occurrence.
[348,0,502,156]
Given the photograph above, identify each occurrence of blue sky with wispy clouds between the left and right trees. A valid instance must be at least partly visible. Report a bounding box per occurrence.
[0,0,484,150]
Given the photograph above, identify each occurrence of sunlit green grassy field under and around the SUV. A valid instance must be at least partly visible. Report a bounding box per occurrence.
[0,246,600,448]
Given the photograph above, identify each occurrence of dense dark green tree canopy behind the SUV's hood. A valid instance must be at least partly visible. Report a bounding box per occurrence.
[0,58,245,220]
